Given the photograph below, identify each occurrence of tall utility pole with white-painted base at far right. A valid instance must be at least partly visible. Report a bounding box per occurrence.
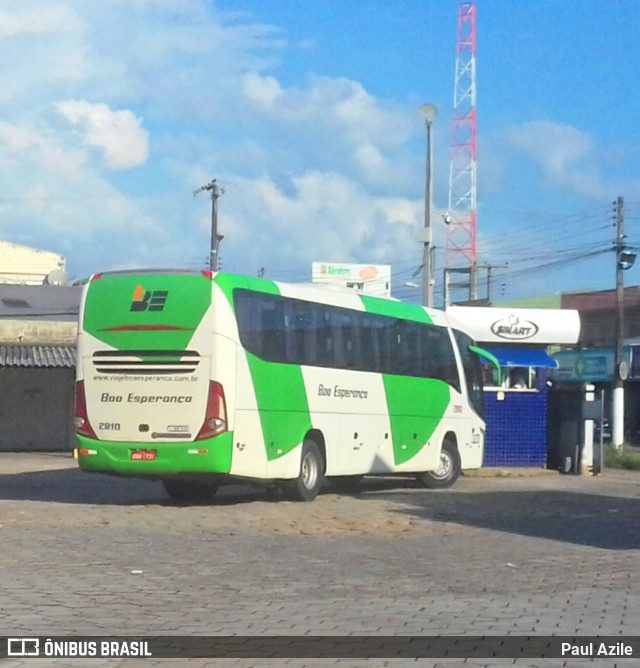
[612,197,633,448]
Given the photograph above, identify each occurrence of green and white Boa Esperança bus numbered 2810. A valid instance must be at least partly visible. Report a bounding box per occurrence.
[76,270,490,501]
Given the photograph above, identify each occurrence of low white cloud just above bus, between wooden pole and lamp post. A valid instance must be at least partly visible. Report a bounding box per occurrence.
[216,172,422,281]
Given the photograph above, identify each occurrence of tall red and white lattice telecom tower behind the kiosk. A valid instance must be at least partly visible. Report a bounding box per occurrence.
[445,2,477,303]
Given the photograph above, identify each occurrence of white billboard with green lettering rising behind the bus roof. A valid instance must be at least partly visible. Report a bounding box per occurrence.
[311,262,391,297]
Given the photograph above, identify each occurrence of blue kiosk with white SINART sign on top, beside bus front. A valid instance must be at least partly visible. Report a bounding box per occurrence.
[447,306,580,468]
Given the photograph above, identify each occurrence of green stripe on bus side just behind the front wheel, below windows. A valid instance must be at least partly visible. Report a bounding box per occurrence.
[383,375,451,465]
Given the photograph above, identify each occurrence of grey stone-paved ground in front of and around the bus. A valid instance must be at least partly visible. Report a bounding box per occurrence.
[0,453,640,668]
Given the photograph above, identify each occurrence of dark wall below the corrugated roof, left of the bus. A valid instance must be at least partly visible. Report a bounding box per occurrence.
[0,367,75,452]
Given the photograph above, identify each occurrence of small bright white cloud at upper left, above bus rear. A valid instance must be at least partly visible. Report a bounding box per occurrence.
[56,100,149,169]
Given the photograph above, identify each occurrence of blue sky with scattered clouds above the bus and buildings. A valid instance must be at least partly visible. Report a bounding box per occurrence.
[0,0,640,304]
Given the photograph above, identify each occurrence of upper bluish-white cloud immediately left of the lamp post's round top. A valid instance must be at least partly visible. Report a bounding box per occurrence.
[240,73,422,193]
